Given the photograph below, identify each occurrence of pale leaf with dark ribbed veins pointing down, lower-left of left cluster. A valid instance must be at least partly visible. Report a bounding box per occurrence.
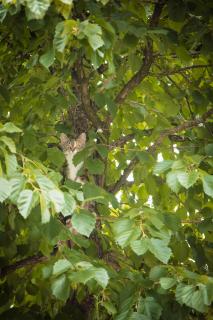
[17,189,33,219]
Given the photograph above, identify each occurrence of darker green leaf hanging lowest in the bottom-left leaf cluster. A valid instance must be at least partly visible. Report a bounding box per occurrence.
[51,275,70,301]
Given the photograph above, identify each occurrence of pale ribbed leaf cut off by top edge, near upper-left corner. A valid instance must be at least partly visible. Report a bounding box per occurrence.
[26,0,51,20]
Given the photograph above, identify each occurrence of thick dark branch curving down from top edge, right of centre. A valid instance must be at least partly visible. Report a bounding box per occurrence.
[115,2,163,104]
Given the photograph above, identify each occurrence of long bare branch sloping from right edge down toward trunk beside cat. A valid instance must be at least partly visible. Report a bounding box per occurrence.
[108,108,213,193]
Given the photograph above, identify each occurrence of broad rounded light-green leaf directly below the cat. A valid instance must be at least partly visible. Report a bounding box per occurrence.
[72,209,96,237]
